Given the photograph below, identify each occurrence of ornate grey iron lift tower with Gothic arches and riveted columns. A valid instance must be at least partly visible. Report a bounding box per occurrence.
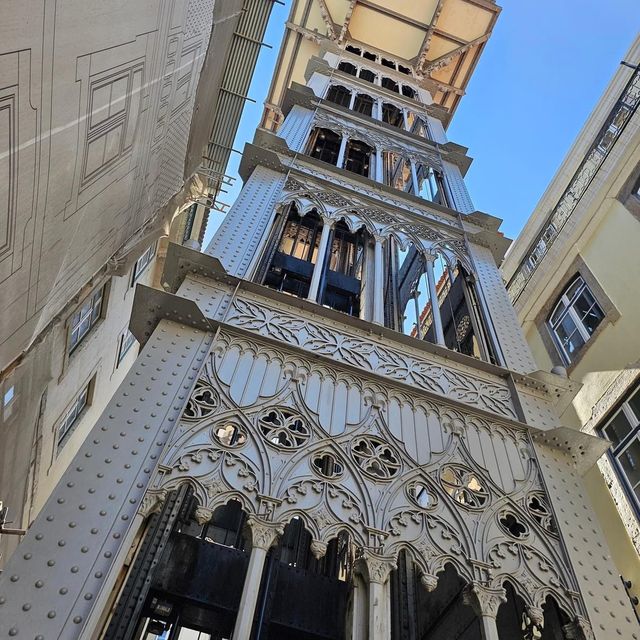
[0,0,640,640]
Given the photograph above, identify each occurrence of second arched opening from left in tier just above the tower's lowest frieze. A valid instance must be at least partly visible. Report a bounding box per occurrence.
[321,221,366,316]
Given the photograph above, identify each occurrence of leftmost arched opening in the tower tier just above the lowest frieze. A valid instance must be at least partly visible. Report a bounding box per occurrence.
[264,206,322,297]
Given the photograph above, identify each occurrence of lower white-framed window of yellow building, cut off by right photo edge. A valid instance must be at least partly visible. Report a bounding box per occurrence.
[600,387,640,510]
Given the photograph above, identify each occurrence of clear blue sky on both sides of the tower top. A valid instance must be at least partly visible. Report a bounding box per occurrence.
[205,0,640,246]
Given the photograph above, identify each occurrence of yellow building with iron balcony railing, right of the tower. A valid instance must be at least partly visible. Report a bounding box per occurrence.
[501,39,640,606]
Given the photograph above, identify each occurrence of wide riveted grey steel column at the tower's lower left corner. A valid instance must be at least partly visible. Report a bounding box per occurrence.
[0,320,213,640]
